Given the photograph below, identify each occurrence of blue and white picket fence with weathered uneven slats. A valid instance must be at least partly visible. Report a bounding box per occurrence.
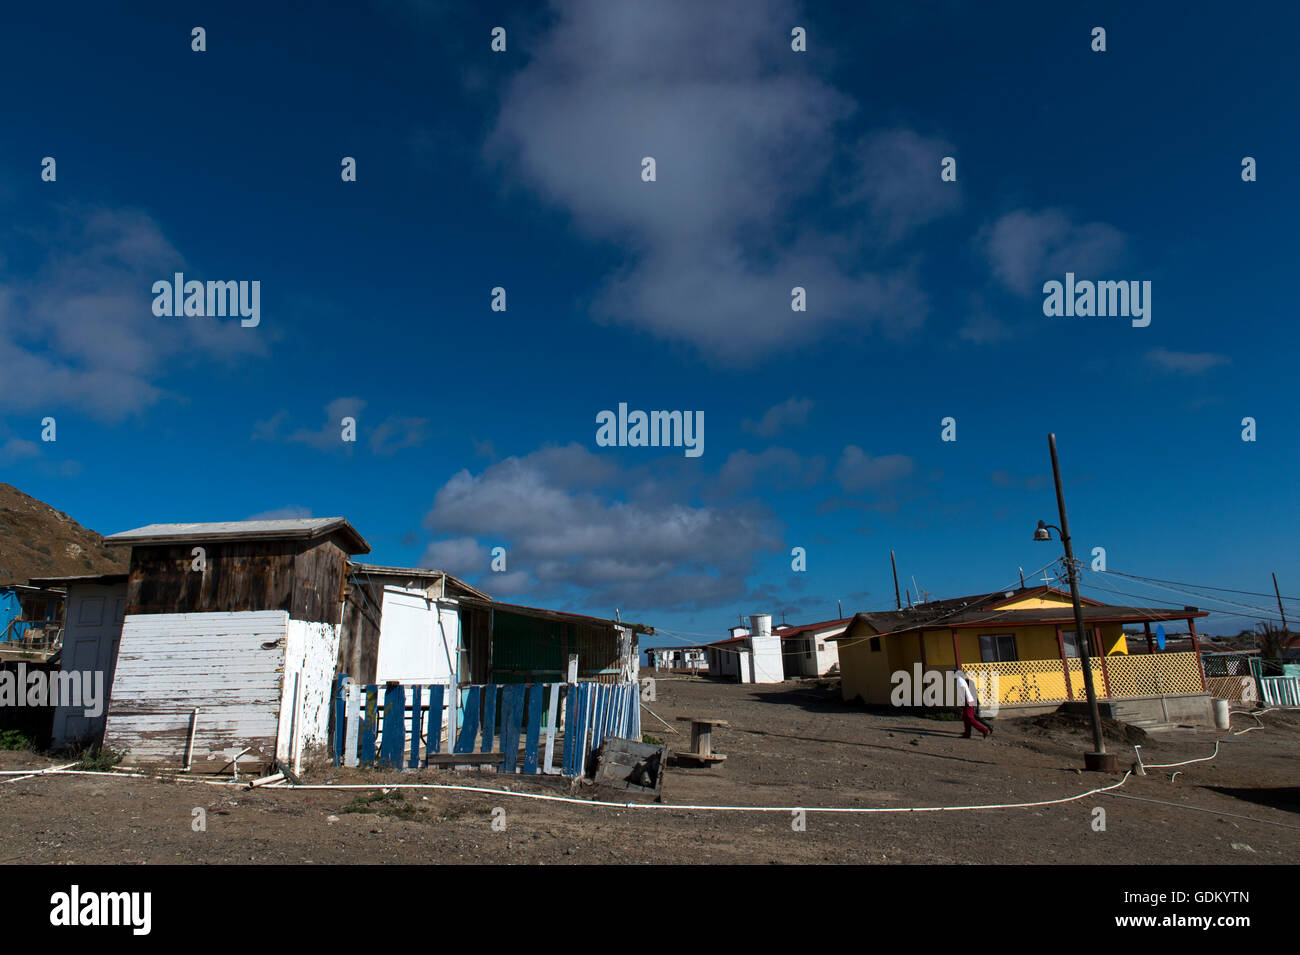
[334,677,641,777]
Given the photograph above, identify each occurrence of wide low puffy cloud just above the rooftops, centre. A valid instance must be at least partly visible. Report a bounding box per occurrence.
[425,444,779,609]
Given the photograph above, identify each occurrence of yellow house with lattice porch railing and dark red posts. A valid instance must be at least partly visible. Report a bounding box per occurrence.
[833,586,1208,709]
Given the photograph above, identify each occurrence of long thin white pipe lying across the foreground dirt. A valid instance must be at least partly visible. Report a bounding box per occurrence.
[0,769,1132,813]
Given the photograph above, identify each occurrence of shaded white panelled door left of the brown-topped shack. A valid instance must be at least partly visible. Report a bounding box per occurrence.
[52,581,126,748]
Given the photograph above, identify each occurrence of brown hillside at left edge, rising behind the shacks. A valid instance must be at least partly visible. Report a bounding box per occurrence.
[0,483,127,585]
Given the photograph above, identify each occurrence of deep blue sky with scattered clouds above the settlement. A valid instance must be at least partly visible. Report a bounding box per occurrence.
[0,0,1300,638]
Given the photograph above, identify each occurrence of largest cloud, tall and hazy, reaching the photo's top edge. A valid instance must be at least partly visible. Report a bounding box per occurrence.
[485,0,948,364]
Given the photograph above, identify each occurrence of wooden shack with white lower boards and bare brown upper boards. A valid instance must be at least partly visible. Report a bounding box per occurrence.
[104,517,369,772]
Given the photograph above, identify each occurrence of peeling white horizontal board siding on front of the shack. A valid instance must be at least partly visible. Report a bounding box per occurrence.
[104,611,288,773]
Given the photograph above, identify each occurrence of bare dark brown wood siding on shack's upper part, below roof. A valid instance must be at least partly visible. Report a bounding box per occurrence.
[126,541,347,624]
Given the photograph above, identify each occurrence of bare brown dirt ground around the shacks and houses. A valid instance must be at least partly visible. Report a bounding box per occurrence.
[0,674,1300,865]
